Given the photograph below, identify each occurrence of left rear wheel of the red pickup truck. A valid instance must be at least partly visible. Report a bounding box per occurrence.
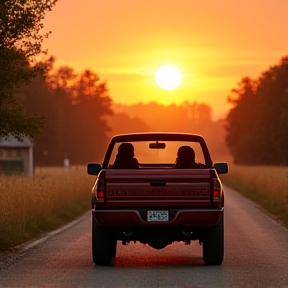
[92,215,116,266]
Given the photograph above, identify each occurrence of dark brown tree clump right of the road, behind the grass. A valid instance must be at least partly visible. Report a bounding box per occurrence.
[226,57,288,165]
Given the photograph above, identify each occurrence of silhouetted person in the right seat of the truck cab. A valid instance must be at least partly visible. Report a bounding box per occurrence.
[174,146,205,169]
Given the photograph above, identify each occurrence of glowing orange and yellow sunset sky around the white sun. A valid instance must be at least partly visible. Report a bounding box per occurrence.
[43,0,288,118]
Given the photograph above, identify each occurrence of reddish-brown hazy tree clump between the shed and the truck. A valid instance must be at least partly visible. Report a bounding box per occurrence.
[17,59,113,166]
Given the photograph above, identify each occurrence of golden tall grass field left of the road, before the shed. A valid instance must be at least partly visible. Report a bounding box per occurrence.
[0,166,95,251]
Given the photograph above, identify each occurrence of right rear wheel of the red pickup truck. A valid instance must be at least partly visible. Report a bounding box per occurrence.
[203,215,224,265]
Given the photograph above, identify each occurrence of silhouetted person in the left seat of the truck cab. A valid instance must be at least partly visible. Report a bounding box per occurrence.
[111,143,139,169]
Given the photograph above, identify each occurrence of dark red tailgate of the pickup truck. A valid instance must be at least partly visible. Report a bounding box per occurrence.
[105,169,211,208]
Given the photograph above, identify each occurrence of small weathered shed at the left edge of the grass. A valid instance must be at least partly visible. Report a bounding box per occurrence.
[0,136,33,176]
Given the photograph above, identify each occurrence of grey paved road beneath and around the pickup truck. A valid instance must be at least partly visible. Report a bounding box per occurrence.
[0,187,288,288]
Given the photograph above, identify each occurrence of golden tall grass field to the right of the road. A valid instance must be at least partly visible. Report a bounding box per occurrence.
[221,165,288,228]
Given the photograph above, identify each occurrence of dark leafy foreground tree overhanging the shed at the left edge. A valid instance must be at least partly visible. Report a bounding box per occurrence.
[0,0,57,139]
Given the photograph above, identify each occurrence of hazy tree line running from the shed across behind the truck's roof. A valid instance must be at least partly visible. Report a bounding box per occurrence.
[16,58,230,166]
